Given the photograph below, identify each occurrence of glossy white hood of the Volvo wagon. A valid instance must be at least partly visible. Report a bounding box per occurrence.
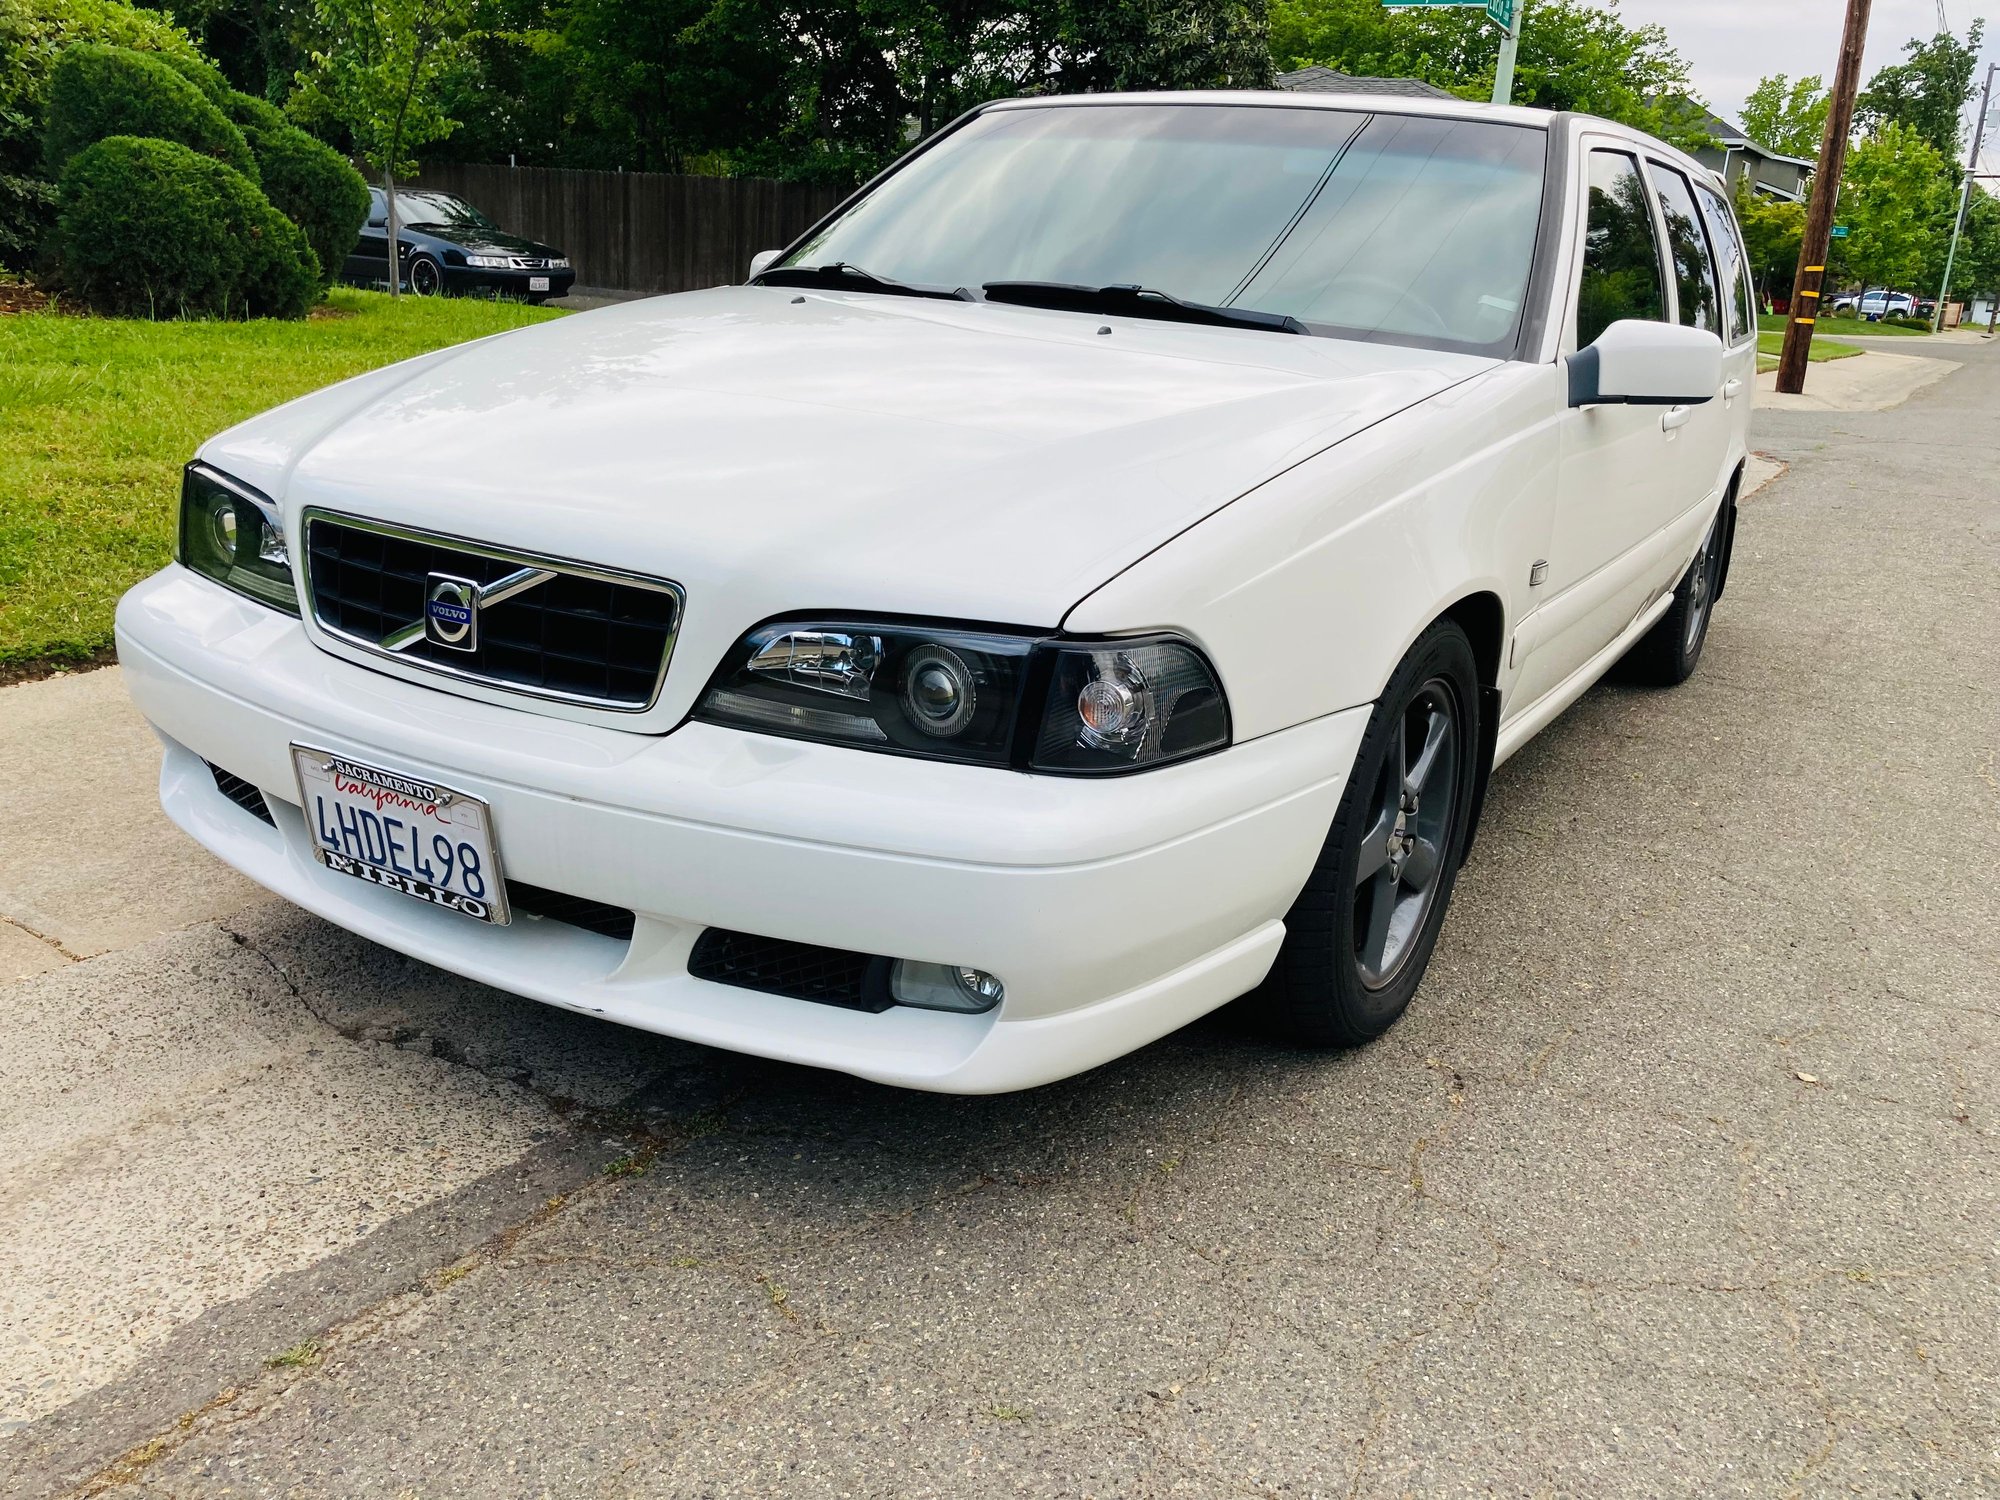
[202,286,1494,724]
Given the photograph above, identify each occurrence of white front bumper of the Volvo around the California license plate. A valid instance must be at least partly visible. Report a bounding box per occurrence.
[118,566,1368,1094]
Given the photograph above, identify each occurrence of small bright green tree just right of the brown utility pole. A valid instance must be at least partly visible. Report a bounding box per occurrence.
[1834,124,1958,300]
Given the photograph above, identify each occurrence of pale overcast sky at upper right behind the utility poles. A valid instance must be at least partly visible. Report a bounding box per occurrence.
[1616,0,2000,142]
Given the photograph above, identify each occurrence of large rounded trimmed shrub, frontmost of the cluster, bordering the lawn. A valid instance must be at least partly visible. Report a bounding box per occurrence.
[56,136,320,318]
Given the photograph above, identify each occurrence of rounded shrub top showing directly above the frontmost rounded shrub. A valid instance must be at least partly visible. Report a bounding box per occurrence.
[42,42,258,182]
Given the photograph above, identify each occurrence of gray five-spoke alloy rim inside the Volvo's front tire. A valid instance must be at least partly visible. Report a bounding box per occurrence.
[1354,678,1464,990]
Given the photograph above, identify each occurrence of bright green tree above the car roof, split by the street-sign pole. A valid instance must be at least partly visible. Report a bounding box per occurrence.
[1270,0,1706,144]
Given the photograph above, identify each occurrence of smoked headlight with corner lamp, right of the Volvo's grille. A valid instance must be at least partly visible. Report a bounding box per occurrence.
[694,620,1230,776]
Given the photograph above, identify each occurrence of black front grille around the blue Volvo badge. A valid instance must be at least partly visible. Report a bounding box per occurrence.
[306,512,680,710]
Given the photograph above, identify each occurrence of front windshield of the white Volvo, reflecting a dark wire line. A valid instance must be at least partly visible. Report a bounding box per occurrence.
[782,104,1548,352]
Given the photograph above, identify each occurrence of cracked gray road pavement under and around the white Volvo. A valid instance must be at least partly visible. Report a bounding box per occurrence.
[0,346,2000,1500]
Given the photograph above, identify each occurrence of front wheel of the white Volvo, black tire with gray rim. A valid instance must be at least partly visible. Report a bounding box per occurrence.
[1248,620,1484,1046]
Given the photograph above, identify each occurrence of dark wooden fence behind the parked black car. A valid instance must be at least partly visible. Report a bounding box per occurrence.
[398,162,846,292]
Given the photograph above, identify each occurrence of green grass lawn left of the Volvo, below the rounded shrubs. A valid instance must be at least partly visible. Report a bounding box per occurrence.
[0,288,562,682]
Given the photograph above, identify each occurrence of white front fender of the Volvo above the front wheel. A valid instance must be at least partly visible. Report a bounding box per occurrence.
[1064,364,1564,740]
